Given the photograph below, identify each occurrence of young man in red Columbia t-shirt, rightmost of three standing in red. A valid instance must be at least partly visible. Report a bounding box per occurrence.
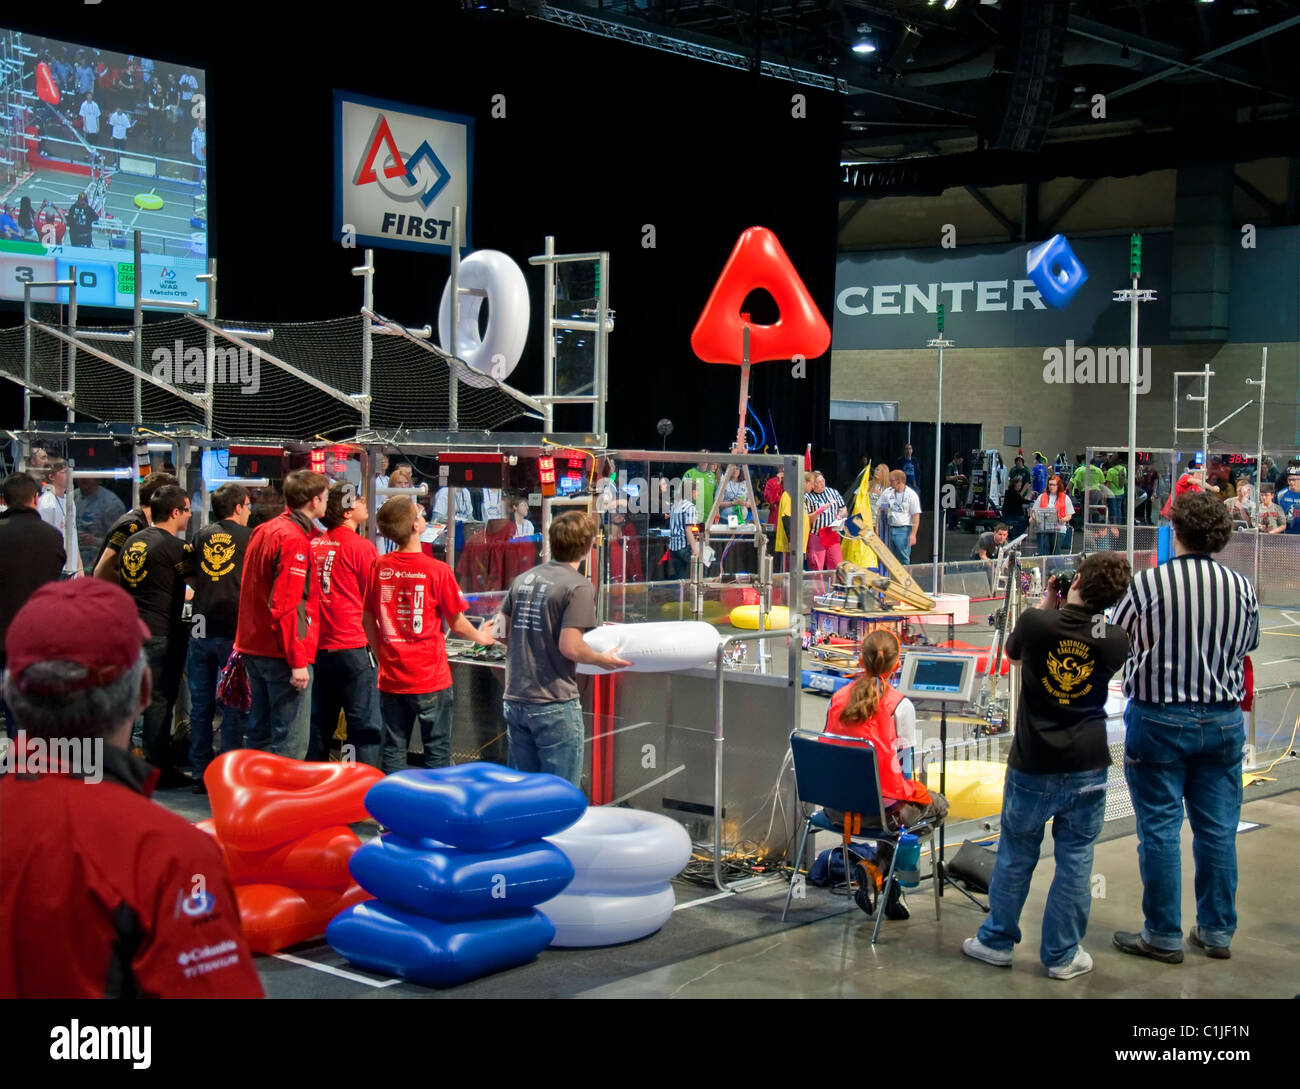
[363,495,495,775]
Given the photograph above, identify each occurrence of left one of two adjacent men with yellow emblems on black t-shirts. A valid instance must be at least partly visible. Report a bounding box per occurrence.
[117,485,192,790]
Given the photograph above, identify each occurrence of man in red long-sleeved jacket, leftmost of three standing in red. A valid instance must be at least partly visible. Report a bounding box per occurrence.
[235,469,329,760]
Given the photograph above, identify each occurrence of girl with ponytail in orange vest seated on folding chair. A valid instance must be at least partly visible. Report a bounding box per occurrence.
[826,630,948,919]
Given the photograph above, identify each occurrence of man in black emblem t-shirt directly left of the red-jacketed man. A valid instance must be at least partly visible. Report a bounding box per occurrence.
[185,483,252,794]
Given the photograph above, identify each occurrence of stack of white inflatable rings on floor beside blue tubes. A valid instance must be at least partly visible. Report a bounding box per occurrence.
[537,806,690,947]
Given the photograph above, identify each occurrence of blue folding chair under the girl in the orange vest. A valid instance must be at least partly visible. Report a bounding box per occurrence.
[781,730,943,945]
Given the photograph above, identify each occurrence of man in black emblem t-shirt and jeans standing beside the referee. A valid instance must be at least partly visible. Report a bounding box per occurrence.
[962,552,1131,980]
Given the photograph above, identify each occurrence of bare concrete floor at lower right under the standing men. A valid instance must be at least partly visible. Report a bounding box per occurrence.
[581,790,1300,999]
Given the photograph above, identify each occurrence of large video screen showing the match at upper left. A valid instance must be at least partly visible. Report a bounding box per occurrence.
[0,27,208,309]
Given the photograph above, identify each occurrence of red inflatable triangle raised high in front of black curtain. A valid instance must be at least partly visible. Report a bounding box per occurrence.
[690,227,831,365]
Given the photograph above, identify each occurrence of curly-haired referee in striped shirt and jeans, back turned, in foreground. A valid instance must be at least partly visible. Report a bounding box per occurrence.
[1113,491,1260,964]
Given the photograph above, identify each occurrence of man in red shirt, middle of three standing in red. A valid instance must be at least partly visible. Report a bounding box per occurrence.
[307,481,381,768]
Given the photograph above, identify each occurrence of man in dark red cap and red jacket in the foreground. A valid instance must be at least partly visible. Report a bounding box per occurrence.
[0,578,263,998]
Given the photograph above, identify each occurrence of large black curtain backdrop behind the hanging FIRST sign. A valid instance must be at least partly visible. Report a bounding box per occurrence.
[0,0,841,451]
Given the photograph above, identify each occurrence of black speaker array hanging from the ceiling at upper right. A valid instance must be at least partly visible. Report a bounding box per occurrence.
[985,0,1070,151]
